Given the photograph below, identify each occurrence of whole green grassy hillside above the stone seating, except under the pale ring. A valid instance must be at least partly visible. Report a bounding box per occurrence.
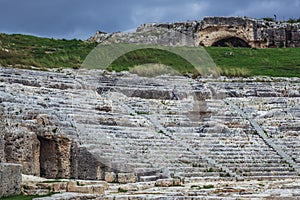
[0,34,300,77]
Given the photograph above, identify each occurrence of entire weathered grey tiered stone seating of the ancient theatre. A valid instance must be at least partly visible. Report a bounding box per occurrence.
[0,68,300,182]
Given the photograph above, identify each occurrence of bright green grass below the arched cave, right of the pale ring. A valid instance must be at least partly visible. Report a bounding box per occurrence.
[206,47,300,77]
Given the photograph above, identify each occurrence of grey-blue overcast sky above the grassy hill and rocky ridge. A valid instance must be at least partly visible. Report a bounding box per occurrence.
[0,0,300,39]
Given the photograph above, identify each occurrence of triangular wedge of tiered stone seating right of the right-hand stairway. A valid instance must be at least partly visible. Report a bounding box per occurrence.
[232,97,300,170]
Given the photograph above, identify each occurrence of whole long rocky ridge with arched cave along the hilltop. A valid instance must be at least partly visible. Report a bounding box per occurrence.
[90,17,300,48]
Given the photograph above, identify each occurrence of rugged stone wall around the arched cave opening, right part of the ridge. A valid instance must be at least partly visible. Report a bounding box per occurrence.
[197,17,300,48]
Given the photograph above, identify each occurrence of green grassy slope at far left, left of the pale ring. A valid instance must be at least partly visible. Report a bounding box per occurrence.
[0,34,96,69]
